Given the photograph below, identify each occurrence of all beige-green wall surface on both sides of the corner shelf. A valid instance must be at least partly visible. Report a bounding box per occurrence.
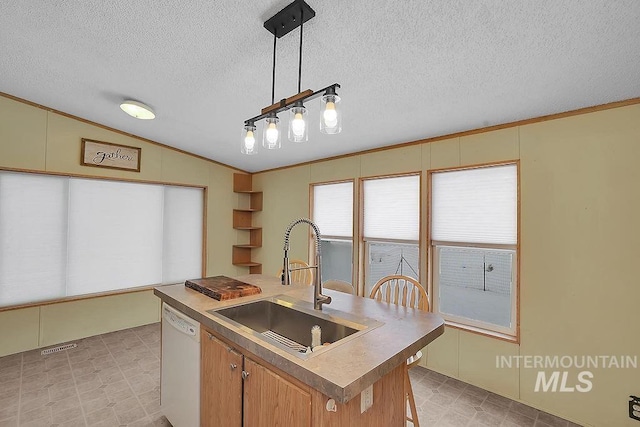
[0,93,640,427]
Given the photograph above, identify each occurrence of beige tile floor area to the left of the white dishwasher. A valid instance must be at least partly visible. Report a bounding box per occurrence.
[0,323,170,427]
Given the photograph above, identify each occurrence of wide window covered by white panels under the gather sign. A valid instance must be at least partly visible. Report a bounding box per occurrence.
[0,172,204,306]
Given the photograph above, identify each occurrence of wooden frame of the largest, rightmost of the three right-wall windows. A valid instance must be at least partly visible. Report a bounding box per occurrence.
[426,159,521,343]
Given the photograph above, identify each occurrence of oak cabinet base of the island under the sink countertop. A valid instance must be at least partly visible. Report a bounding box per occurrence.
[200,327,406,427]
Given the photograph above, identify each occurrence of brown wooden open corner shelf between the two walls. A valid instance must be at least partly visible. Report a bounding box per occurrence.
[231,173,262,274]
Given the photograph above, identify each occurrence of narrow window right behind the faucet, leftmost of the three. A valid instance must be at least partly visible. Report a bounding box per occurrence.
[312,182,353,283]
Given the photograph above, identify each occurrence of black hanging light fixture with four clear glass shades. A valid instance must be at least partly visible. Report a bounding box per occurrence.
[241,0,342,154]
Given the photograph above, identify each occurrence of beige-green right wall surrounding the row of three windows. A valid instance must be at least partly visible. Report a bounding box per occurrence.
[254,105,640,427]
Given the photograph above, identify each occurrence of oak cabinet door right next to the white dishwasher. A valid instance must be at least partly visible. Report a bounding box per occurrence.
[200,328,242,427]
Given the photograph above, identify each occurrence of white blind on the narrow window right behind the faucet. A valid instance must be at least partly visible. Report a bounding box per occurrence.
[313,182,353,237]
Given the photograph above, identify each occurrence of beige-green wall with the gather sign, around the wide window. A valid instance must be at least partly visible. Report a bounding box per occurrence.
[0,96,242,356]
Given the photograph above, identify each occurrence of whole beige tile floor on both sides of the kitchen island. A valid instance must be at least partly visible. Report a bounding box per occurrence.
[0,323,576,427]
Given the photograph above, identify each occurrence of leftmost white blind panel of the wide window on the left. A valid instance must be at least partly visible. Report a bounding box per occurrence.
[0,172,68,306]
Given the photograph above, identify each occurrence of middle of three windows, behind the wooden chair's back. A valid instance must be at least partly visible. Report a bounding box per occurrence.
[362,175,420,296]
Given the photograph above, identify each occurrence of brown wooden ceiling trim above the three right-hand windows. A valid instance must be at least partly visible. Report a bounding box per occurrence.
[253,98,640,175]
